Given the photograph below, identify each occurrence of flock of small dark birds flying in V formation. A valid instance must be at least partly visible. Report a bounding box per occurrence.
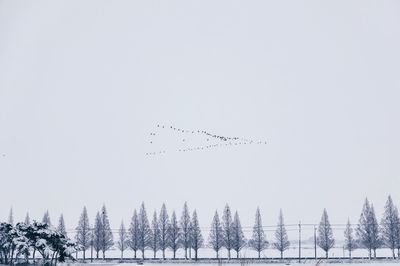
[146,124,268,156]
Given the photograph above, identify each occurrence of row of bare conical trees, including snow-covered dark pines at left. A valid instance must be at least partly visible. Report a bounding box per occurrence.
[0,196,400,263]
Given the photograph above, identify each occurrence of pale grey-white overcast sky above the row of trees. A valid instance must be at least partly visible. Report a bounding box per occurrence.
[0,0,400,235]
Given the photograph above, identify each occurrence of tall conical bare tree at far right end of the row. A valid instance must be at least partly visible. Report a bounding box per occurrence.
[381,195,399,258]
